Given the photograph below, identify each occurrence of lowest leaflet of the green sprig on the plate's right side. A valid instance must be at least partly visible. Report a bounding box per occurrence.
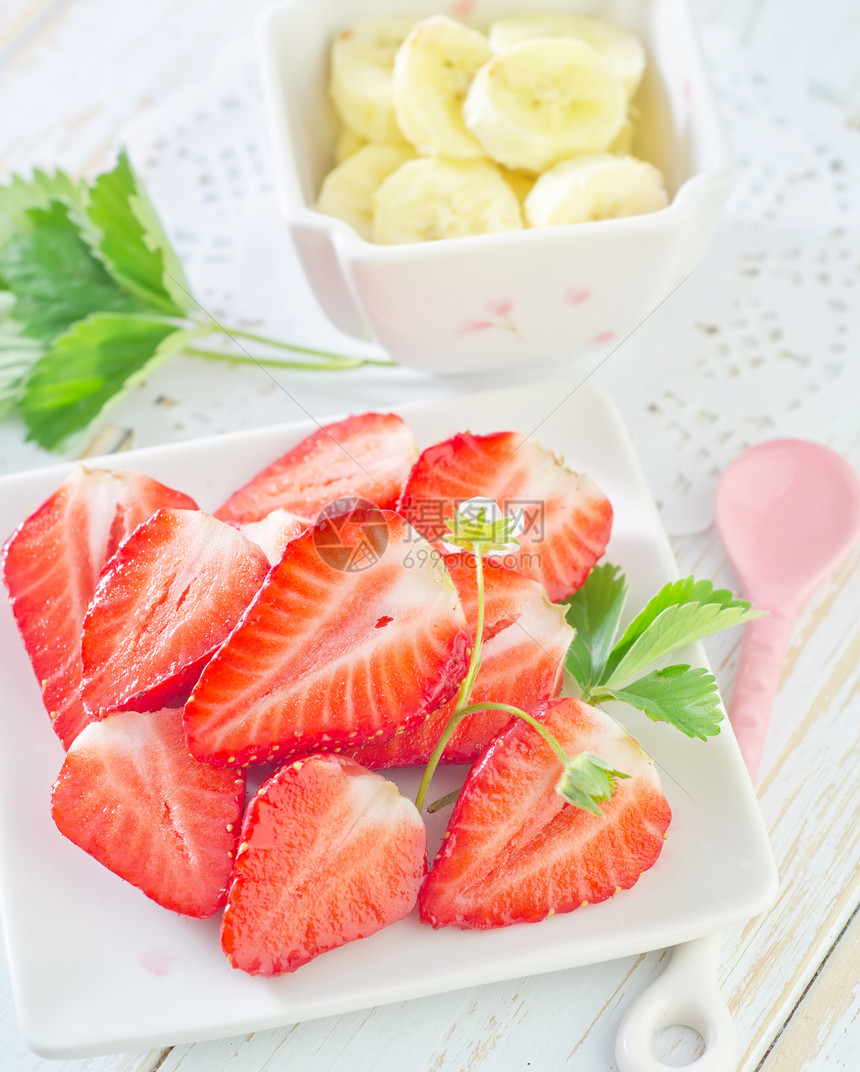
[596,665,723,741]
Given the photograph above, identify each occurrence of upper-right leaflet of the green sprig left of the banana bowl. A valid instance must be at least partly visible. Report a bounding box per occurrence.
[86,150,193,316]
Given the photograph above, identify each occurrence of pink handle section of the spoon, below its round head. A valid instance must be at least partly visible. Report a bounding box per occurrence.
[728,609,794,785]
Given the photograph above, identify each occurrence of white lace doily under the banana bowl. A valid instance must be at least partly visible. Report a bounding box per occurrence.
[6,0,860,534]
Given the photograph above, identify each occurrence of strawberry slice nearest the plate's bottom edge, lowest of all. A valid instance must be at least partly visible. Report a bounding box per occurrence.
[221,755,427,976]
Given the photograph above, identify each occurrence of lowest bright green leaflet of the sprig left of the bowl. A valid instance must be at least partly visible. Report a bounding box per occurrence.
[20,313,190,450]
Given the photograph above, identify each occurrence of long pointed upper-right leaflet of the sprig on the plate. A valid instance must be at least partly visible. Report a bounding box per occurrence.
[600,577,761,686]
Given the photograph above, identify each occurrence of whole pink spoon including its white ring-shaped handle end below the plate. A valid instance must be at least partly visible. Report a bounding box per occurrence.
[616,440,860,1072]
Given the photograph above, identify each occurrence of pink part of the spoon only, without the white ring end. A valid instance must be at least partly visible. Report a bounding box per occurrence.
[715,440,860,784]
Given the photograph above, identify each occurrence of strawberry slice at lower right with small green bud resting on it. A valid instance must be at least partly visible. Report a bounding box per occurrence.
[419,699,671,928]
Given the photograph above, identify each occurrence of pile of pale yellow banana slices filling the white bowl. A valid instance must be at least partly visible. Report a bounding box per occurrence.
[315,12,666,244]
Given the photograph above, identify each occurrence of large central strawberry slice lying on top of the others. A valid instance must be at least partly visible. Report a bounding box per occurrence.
[186,510,470,763]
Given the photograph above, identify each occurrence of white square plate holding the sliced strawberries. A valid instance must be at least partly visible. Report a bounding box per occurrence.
[0,383,776,1057]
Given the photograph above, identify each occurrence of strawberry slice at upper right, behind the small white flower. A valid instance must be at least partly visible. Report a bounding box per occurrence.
[398,432,612,602]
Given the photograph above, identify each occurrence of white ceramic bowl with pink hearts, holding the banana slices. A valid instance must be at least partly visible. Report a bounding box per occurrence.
[257,0,731,374]
